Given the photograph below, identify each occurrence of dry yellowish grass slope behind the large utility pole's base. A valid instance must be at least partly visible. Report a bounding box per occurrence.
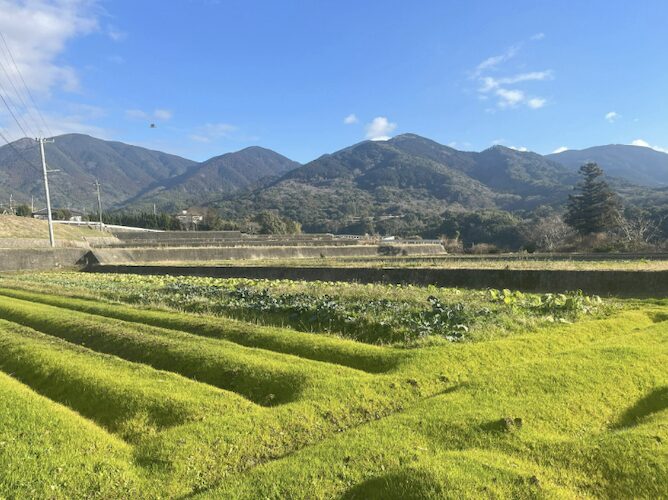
[0,215,103,240]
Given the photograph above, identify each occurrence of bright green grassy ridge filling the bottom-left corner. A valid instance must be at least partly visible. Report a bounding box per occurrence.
[0,372,147,498]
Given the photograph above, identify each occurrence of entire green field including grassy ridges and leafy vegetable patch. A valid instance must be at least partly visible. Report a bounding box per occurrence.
[0,273,668,499]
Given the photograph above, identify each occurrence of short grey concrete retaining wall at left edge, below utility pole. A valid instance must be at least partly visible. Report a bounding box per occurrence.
[0,248,90,272]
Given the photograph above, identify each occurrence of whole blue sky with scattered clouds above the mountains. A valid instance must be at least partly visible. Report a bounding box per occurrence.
[0,0,668,162]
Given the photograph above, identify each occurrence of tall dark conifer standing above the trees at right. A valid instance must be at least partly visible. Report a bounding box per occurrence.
[564,163,619,235]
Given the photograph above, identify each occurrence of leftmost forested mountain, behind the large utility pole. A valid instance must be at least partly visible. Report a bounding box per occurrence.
[0,134,195,208]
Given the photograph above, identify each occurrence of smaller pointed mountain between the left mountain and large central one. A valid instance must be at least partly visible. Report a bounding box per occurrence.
[126,146,300,209]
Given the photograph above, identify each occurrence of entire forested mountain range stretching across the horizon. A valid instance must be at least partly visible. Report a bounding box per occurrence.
[0,134,668,227]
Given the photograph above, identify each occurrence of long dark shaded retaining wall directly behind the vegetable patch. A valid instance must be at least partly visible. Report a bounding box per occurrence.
[90,265,668,298]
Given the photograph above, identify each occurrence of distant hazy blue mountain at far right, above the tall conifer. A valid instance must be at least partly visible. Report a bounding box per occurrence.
[546,144,668,187]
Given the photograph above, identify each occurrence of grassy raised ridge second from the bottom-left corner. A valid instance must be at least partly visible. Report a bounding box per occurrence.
[0,320,254,440]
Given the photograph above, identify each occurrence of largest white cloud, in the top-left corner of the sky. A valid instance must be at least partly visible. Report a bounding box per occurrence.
[0,0,99,95]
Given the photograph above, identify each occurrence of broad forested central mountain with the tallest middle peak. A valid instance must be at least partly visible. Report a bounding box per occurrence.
[215,134,576,230]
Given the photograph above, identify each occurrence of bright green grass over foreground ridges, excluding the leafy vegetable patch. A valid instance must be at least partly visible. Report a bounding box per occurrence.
[0,274,668,498]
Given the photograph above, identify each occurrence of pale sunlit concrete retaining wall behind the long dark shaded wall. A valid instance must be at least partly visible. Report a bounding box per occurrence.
[88,245,443,264]
